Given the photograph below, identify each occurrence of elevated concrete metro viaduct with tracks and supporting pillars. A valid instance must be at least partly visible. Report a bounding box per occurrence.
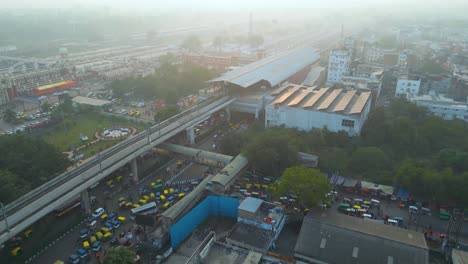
[0,96,235,244]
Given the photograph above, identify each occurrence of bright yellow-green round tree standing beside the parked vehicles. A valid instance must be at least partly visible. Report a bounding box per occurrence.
[277,167,331,208]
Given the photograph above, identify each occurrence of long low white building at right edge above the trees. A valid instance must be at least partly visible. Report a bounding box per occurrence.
[406,92,468,122]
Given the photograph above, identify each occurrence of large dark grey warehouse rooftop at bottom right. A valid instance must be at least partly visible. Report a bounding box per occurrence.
[294,209,429,263]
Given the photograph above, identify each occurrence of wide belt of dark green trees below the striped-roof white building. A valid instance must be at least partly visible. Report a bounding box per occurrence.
[220,99,468,206]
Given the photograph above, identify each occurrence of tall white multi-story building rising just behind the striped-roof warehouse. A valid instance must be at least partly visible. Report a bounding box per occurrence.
[327,50,351,85]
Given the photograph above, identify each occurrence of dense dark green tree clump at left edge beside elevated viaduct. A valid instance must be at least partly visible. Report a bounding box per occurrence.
[0,135,69,203]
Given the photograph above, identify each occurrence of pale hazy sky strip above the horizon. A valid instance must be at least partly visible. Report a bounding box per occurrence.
[5,0,468,11]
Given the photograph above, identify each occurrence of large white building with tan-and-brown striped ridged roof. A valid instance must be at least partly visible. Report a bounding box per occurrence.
[265,84,372,135]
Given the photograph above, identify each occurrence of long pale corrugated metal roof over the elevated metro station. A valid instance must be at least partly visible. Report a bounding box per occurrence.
[209,47,320,88]
